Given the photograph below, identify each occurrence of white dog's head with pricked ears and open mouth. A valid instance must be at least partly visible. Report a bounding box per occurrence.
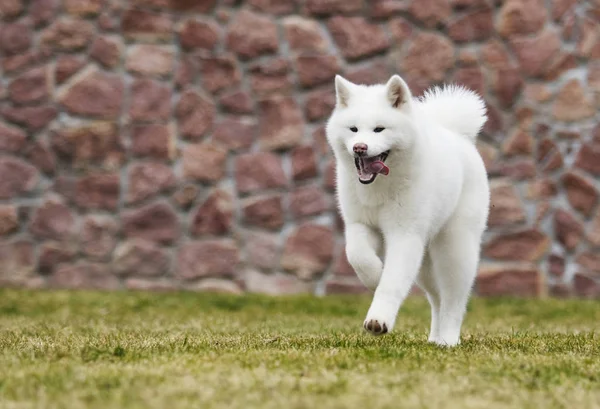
[327,75,415,184]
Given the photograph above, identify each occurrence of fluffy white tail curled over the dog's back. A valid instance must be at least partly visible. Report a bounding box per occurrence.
[420,85,487,143]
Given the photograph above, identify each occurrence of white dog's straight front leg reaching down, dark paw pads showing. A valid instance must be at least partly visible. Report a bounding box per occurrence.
[364,234,424,335]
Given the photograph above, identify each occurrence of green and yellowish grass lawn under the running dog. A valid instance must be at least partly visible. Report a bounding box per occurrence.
[0,290,600,409]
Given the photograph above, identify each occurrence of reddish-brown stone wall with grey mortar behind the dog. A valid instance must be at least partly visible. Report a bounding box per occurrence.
[0,0,600,297]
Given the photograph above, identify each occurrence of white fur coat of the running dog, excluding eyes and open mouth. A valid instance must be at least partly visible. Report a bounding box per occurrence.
[327,75,490,346]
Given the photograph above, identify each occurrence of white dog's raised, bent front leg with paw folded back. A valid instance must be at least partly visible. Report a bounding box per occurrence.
[346,223,383,291]
